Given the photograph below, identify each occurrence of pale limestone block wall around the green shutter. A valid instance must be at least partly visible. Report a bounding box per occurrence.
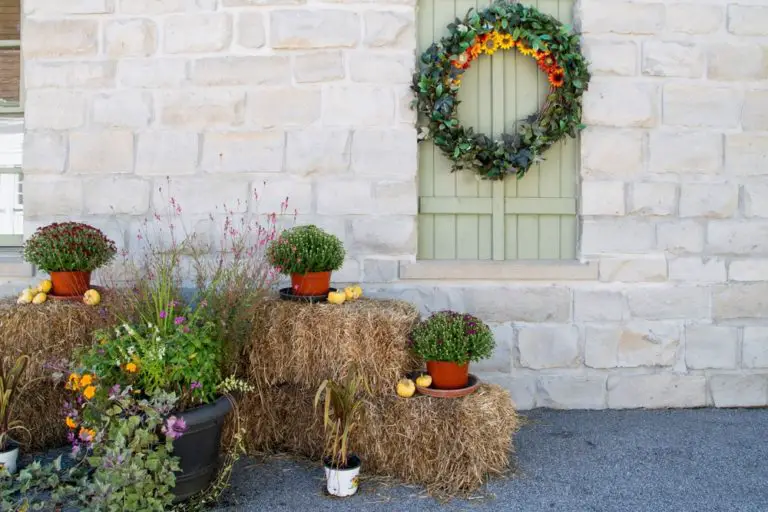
[23,0,768,408]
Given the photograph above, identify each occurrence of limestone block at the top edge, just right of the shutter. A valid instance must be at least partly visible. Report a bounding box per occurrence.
[580,0,664,34]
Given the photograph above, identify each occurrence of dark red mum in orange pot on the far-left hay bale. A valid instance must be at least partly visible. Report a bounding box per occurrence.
[24,222,117,297]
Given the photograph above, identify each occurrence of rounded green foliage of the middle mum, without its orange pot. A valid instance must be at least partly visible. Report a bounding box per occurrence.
[267,225,345,275]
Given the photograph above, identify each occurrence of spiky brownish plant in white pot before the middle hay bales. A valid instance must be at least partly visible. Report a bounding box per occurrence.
[315,373,366,497]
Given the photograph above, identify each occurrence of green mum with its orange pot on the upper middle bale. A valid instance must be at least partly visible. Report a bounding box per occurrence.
[267,225,345,296]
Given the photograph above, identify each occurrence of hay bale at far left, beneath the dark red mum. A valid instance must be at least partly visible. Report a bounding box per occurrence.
[0,294,130,450]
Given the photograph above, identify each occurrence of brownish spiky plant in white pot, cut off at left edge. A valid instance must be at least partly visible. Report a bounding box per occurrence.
[0,355,29,474]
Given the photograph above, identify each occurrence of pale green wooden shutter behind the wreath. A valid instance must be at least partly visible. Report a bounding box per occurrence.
[418,0,579,260]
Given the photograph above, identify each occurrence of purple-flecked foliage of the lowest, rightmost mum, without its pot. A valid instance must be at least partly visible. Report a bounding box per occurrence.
[409,311,495,365]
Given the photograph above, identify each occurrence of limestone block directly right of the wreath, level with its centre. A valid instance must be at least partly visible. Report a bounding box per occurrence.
[583,79,660,128]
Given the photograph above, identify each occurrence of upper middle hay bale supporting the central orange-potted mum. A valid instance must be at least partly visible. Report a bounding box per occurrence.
[246,299,419,393]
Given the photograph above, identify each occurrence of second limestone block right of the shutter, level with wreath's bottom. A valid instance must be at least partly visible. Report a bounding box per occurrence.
[649,130,723,173]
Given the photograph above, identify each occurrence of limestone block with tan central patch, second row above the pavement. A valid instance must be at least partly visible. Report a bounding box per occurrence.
[584,321,680,368]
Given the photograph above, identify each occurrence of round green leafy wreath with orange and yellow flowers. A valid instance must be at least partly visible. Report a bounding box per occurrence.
[411,0,590,179]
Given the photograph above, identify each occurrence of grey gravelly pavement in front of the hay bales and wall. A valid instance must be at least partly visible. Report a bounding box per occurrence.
[213,409,768,512]
